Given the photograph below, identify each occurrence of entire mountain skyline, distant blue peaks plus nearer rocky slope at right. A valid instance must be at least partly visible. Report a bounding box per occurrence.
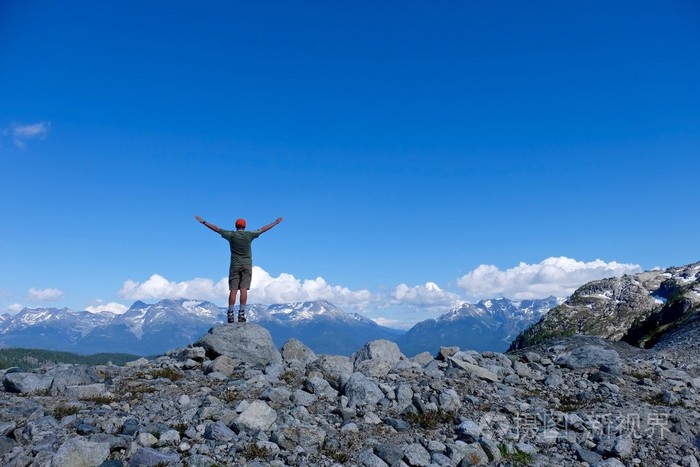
[10,256,700,357]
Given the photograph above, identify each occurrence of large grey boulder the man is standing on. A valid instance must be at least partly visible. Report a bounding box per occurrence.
[194,323,282,366]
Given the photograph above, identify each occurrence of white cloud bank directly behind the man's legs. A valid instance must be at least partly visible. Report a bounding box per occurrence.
[119,266,372,309]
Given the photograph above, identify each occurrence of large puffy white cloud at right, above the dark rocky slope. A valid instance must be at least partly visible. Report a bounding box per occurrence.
[457,256,642,300]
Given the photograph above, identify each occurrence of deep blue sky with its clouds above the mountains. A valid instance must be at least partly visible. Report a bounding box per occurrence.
[0,0,700,327]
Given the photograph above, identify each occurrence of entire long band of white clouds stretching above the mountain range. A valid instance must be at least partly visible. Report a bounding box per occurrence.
[116,257,641,329]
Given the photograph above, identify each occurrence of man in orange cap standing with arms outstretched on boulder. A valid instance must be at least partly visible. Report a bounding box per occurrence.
[194,216,282,323]
